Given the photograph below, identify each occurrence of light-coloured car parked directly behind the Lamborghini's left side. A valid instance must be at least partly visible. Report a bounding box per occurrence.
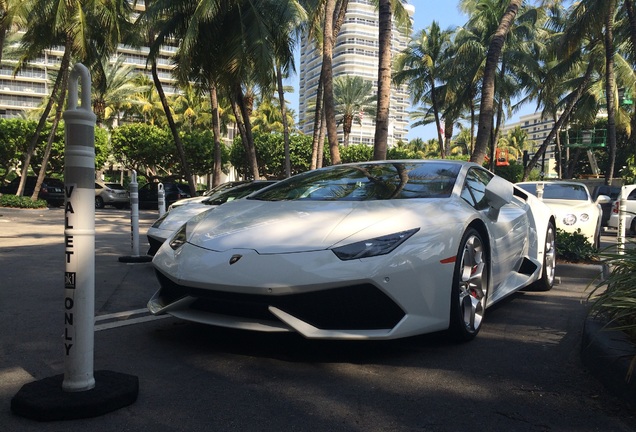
[147,180,275,255]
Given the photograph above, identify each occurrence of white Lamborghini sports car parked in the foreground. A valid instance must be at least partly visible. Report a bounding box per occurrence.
[148,160,555,341]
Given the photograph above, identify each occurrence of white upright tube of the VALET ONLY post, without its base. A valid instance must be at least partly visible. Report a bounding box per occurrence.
[62,64,96,392]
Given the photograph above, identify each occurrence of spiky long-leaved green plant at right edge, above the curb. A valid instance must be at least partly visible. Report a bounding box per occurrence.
[589,243,636,341]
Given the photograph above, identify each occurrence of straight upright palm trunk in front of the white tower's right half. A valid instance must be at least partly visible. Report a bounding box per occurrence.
[373,0,392,160]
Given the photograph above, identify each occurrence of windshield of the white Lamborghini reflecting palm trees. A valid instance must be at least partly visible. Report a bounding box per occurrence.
[249,162,461,201]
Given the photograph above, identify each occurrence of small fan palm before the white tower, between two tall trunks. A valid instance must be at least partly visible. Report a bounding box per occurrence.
[333,75,375,146]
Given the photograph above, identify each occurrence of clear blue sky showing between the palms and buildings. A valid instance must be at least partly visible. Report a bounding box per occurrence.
[288,0,534,141]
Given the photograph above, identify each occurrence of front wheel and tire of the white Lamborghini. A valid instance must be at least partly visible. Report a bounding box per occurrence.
[449,228,488,342]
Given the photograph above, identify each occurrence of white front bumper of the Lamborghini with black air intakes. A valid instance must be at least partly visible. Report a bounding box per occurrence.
[148,240,453,339]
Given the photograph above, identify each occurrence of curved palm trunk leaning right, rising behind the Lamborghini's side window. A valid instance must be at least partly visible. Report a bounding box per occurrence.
[470,0,522,165]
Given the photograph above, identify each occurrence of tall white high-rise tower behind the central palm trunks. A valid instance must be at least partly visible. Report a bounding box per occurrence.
[298,0,415,147]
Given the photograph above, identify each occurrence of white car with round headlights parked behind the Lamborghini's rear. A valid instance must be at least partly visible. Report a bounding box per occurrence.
[517,180,611,248]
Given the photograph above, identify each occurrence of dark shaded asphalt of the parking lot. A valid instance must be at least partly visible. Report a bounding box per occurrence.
[0,208,636,432]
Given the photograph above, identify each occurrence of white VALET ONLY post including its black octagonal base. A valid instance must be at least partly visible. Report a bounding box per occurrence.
[11,64,139,421]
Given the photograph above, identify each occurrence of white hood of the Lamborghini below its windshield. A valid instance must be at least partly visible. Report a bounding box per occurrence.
[188,199,462,254]
